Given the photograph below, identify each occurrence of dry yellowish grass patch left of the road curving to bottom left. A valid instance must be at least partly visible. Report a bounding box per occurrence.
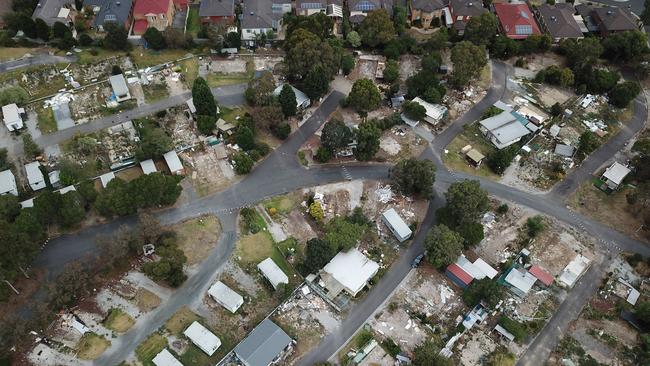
[174,215,221,265]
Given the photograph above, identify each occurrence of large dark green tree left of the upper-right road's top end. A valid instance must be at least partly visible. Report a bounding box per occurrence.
[451,41,487,87]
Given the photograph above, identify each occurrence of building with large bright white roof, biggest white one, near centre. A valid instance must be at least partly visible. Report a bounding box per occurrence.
[320,248,379,299]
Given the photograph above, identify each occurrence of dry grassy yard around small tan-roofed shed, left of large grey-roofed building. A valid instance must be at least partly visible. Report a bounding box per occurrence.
[442,124,500,181]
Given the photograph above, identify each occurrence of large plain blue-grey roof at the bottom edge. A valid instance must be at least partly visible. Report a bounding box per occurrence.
[235,319,291,366]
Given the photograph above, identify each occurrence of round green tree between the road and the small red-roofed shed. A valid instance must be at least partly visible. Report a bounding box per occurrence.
[424,225,463,269]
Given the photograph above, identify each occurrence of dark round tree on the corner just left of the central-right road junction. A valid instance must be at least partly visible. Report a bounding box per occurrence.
[389,158,436,198]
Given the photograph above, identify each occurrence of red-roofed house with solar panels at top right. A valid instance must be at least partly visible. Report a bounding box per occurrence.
[494,3,542,39]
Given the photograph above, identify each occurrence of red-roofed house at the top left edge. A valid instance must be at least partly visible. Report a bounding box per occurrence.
[133,0,176,35]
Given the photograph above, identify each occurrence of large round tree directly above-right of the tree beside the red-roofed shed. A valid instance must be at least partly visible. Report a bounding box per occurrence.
[445,180,490,226]
